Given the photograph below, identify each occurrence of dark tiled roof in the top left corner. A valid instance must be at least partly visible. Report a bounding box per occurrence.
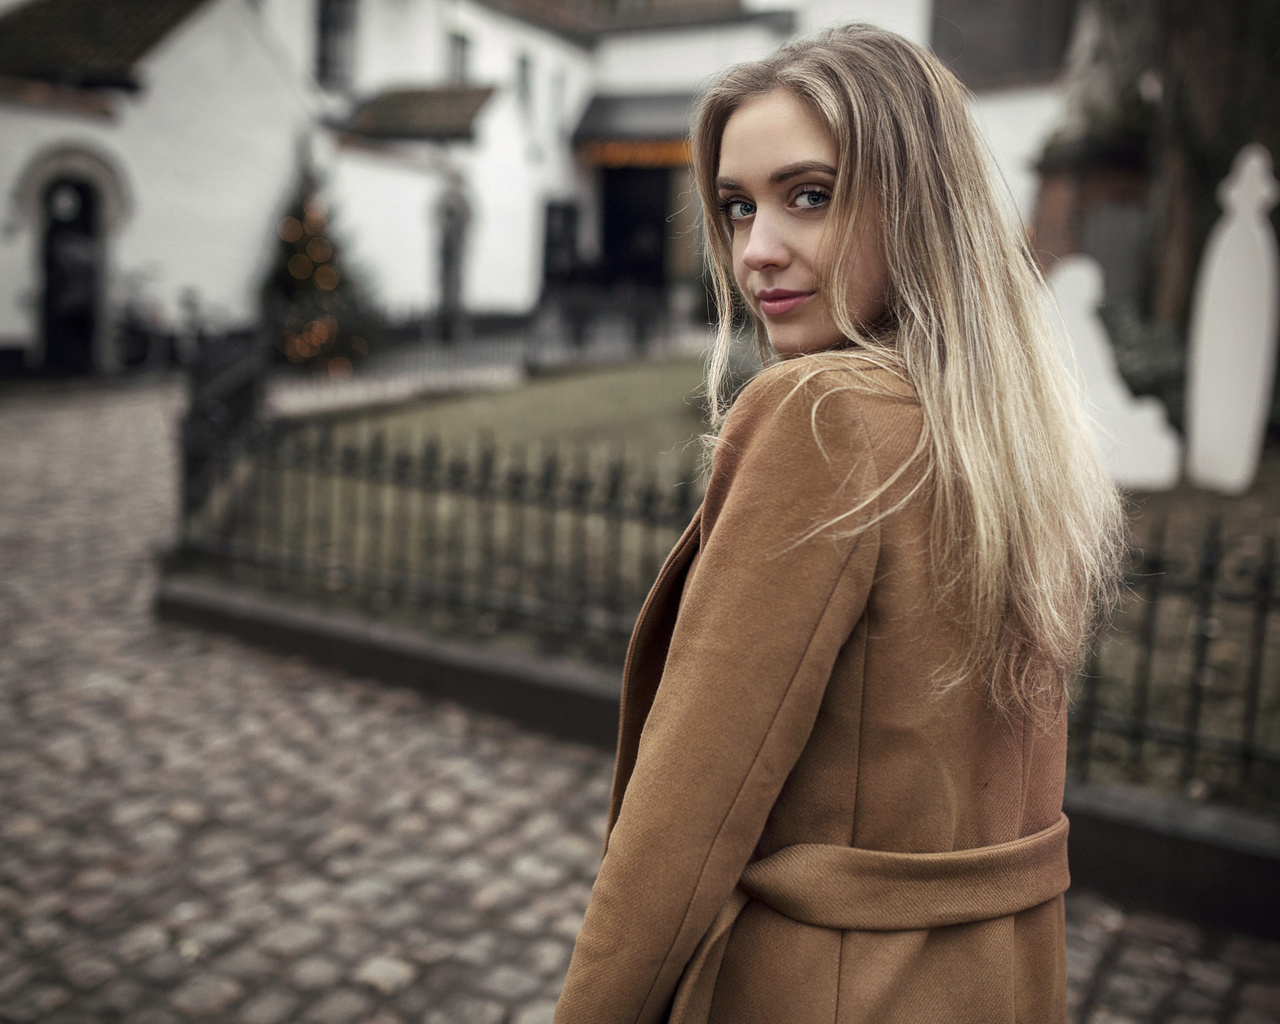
[0,0,205,88]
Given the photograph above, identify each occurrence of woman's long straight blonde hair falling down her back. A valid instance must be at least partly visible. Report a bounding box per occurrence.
[692,26,1124,717]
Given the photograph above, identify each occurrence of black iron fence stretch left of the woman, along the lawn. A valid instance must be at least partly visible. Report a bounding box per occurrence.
[180,421,701,662]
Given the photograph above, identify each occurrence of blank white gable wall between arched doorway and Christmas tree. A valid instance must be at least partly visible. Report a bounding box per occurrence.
[119,0,315,323]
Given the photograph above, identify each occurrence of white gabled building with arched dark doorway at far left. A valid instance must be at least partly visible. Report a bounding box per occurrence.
[0,0,317,370]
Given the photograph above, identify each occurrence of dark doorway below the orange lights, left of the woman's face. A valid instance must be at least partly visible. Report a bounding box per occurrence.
[603,168,671,288]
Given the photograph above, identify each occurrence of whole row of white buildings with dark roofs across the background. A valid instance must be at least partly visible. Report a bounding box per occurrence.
[0,0,1068,371]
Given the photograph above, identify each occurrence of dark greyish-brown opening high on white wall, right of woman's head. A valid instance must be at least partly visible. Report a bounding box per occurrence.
[933,0,1078,90]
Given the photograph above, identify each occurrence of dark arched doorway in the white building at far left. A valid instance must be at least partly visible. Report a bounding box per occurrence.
[41,178,102,374]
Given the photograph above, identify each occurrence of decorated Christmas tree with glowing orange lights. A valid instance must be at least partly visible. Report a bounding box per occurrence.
[261,173,381,380]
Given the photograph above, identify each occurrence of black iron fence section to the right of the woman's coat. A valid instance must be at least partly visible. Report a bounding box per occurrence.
[1070,517,1280,810]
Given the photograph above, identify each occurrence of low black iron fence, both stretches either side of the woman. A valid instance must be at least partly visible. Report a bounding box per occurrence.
[172,421,1280,810]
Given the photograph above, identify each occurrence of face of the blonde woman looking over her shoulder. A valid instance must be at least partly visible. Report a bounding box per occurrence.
[716,88,887,356]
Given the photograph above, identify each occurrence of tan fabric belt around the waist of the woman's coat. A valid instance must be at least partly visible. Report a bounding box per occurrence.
[669,814,1071,1024]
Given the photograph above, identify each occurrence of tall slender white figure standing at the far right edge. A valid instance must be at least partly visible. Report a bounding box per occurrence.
[1187,143,1280,494]
